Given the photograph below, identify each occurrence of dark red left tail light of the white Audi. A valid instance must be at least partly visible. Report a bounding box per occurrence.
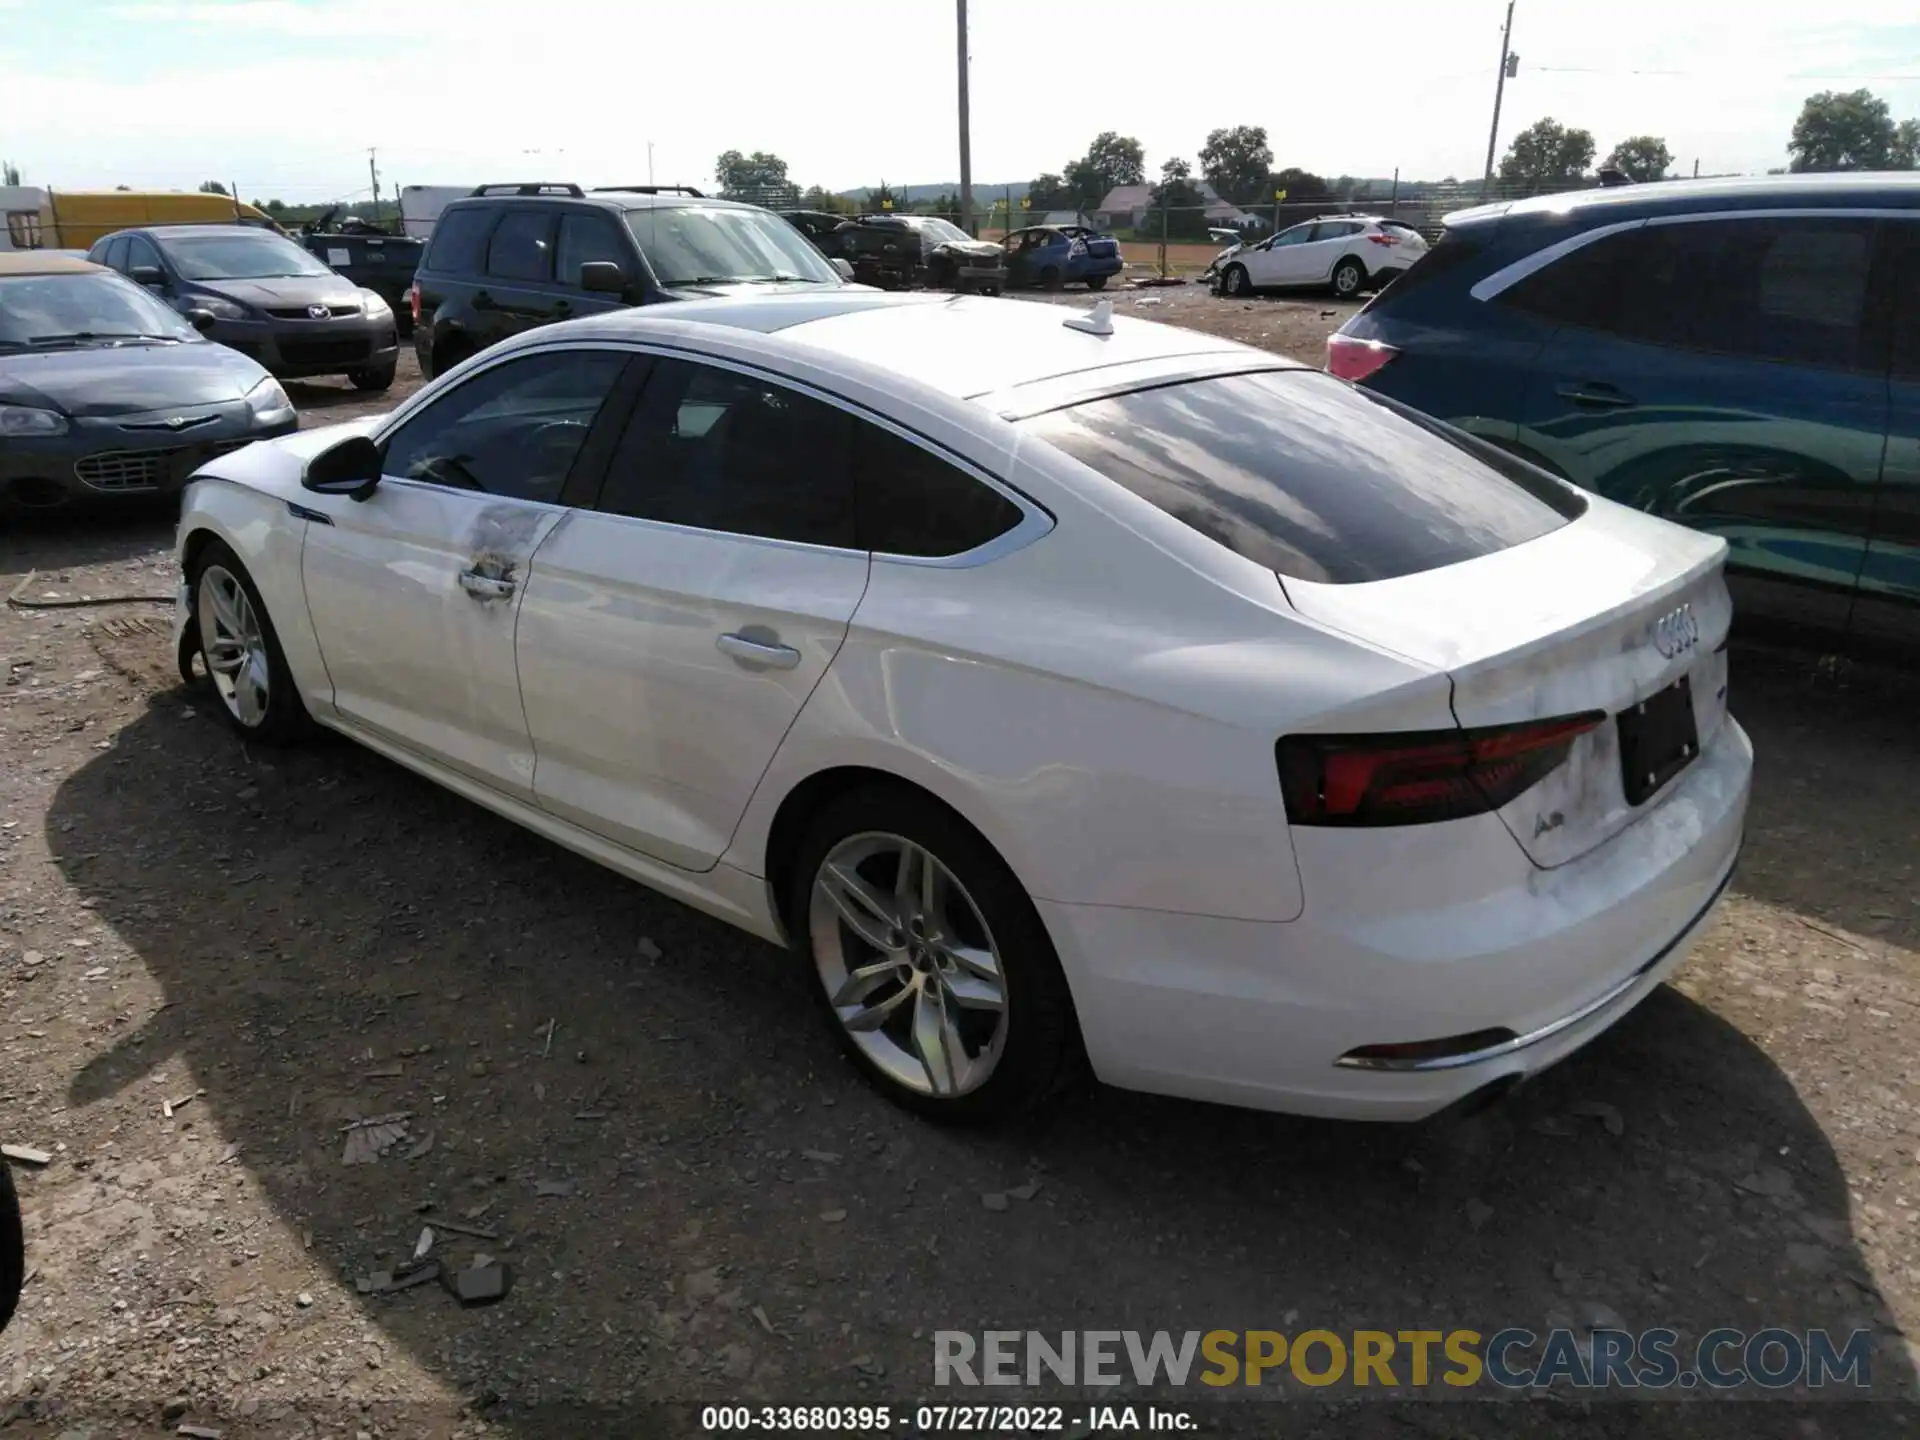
[1277,712,1607,826]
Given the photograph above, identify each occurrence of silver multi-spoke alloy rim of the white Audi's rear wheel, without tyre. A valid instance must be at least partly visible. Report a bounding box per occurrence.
[806,831,1006,1098]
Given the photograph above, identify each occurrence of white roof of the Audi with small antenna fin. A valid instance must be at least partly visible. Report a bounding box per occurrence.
[528,286,1294,399]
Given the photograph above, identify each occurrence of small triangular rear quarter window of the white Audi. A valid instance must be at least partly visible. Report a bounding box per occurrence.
[852,420,1021,557]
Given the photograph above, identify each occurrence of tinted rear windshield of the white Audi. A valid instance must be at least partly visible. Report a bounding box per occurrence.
[1021,371,1586,586]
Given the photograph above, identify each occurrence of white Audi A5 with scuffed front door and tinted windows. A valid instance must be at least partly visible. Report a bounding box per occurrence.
[179,290,1753,1119]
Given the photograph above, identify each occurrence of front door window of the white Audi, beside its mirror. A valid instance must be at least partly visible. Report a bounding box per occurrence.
[380,349,628,505]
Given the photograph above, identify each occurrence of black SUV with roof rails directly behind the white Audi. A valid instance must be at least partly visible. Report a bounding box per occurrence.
[413,184,845,378]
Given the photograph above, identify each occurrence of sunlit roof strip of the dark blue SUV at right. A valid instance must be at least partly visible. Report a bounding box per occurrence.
[1446,171,1920,225]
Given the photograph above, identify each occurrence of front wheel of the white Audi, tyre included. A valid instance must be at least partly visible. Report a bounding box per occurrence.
[188,540,313,745]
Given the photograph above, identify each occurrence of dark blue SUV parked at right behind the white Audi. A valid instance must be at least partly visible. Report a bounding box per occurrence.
[1327,173,1920,657]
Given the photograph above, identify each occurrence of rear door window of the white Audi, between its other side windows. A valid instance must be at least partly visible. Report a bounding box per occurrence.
[599,361,858,549]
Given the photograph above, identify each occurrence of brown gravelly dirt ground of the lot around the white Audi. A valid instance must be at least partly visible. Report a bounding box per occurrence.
[0,299,1920,1440]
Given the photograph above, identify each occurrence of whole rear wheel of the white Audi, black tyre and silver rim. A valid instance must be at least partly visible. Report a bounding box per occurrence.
[787,787,1077,1121]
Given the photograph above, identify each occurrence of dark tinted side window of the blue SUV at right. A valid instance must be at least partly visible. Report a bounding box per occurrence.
[1497,217,1876,369]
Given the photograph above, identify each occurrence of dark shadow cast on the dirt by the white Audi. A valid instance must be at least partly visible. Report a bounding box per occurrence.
[46,668,1914,1436]
